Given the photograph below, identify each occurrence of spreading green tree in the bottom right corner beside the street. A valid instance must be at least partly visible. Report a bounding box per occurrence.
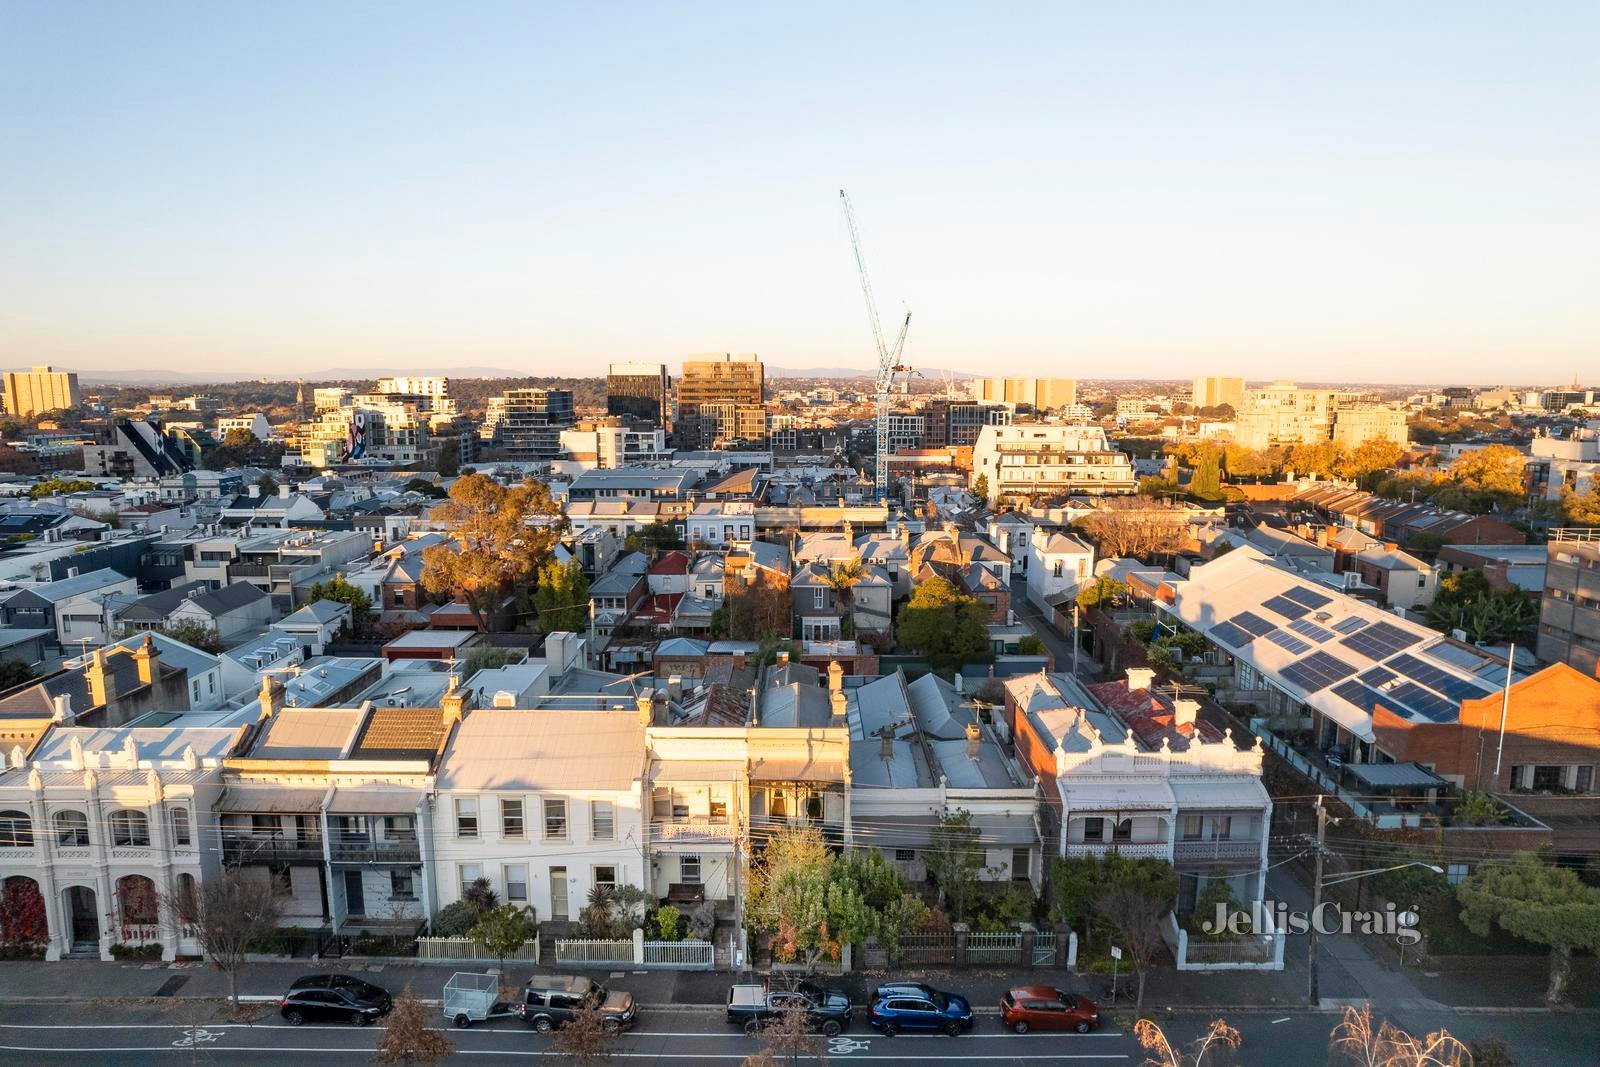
[1456,853,1600,1005]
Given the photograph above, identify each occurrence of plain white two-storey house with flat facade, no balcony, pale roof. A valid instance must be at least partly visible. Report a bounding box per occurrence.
[432,697,646,921]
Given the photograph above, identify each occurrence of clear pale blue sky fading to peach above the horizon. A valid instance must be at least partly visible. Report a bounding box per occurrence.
[0,0,1600,384]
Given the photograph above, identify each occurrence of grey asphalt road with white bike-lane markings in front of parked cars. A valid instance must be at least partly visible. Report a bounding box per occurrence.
[0,1001,1597,1067]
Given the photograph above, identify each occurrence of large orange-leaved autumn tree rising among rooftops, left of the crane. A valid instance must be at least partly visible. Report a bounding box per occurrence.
[422,474,566,630]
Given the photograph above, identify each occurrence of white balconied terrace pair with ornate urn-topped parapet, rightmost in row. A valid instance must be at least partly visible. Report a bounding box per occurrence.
[1056,726,1272,912]
